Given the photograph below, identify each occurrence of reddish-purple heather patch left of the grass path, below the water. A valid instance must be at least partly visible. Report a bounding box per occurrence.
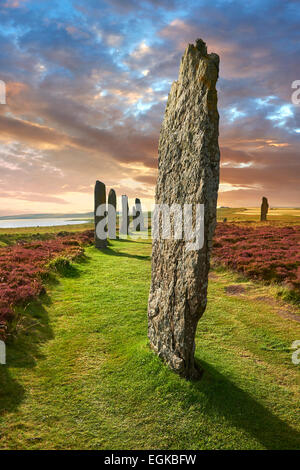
[0,230,93,337]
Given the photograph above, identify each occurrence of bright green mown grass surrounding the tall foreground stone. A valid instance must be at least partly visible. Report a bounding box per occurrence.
[0,241,300,449]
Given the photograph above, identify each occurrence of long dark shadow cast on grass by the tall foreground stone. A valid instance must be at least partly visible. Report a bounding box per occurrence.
[188,361,300,450]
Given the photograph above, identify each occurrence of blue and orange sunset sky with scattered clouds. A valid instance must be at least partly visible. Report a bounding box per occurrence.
[0,0,300,216]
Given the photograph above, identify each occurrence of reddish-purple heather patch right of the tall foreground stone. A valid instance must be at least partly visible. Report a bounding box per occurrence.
[213,223,300,292]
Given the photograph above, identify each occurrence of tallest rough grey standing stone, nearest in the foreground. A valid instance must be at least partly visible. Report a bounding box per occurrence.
[148,39,220,378]
